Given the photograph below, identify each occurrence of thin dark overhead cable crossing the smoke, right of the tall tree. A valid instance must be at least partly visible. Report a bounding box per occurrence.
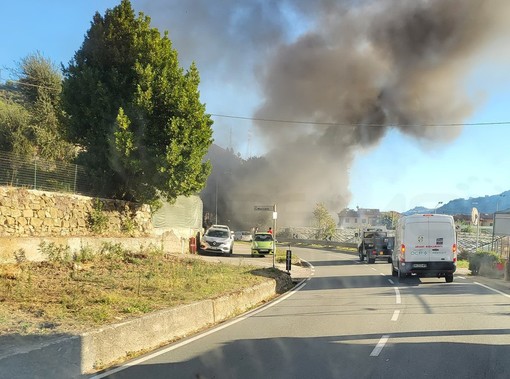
[209,113,510,128]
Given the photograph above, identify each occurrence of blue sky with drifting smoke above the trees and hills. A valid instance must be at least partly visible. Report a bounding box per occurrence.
[0,0,510,217]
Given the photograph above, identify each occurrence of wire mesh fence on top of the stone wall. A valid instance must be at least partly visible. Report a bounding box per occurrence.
[0,151,92,195]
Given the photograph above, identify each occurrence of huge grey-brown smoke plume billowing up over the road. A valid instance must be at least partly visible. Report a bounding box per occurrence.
[134,0,510,225]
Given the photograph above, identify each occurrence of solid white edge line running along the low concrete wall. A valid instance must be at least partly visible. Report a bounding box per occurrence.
[90,265,314,379]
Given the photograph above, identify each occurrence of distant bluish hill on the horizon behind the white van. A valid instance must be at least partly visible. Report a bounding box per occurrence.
[403,191,510,215]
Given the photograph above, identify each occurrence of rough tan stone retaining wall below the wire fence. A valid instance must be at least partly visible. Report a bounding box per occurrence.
[0,187,152,237]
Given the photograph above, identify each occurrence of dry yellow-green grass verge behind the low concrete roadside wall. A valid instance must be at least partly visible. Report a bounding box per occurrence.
[0,244,277,335]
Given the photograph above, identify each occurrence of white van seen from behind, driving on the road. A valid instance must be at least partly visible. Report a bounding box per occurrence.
[391,214,457,283]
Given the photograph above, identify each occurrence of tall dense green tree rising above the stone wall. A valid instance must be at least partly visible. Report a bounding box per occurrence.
[63,0,212,205]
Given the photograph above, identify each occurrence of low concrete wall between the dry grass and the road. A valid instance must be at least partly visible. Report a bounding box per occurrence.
[0,279,286,379]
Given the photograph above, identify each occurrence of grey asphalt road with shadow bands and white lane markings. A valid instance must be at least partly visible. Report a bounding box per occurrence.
[89,249,510,378]
